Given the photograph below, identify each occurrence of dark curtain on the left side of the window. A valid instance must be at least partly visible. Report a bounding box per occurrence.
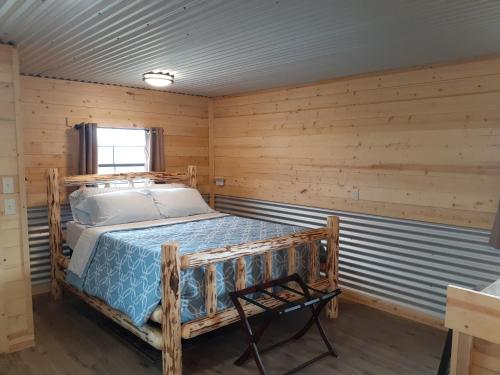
[75,123,97,174]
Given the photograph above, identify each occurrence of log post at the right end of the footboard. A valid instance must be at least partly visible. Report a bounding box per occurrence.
[326,216,339,319]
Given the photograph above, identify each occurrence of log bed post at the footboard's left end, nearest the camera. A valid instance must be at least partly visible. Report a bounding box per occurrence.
[161,243,182,375]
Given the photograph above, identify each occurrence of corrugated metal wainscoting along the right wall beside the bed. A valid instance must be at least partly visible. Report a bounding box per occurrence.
[216,196,500,318]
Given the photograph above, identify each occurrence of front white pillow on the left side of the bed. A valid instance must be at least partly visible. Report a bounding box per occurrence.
[76,190,161,226]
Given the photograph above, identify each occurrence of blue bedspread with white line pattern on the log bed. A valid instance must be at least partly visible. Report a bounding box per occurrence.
[67,216,316,326]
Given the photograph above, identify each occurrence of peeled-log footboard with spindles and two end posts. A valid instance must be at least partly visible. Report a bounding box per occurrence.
[162,216,339,374]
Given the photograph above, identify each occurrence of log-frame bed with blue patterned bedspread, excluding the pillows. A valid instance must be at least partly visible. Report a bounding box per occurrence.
[47,166,339,374]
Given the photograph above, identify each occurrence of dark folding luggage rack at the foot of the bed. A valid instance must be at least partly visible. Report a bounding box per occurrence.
[229,273,341,375]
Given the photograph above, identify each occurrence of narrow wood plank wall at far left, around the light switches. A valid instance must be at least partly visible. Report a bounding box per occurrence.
[0,45,34,353]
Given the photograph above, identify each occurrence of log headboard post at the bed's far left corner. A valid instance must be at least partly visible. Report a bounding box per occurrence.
[47,168,63,300]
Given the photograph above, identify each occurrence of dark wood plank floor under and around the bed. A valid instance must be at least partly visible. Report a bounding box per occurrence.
[0,295,445,375]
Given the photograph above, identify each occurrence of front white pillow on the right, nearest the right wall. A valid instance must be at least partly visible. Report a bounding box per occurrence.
[150,188,214,217]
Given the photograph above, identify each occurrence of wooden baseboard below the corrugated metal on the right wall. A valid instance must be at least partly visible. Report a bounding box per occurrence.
[341,288,447,330]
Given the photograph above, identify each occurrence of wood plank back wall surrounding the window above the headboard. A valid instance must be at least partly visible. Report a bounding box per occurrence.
[21,77,209,207]
